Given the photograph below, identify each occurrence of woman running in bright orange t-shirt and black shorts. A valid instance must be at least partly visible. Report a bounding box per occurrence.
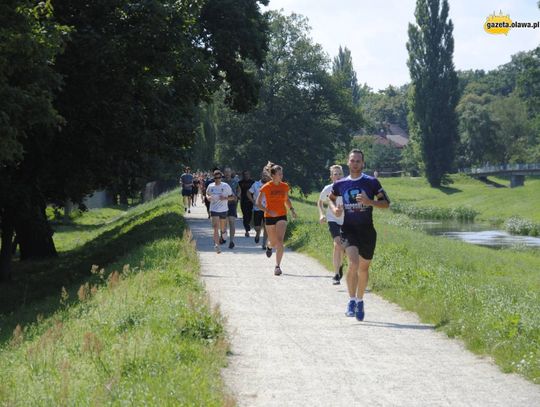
[256,162,296,276]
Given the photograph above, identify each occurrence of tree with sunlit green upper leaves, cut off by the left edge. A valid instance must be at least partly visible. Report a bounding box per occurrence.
[0,0,68,281]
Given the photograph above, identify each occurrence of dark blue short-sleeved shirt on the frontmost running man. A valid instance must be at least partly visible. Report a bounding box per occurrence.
[332,174,384,225]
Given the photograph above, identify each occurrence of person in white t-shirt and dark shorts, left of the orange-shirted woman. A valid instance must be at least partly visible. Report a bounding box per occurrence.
[206,170,235,253]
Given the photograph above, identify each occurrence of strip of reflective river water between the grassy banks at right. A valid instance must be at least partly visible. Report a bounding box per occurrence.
[419,221,540,248]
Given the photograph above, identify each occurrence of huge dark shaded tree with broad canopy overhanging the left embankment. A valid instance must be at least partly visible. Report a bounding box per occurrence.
[0,0,267,282]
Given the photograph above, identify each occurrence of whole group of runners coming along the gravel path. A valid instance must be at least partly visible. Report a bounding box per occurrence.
[181,149,390,321]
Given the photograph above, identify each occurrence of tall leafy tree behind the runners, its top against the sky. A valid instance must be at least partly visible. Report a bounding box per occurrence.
[216,12,361,192]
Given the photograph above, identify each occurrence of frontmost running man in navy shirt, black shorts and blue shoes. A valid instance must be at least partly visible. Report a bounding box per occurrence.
[329,149,390,321]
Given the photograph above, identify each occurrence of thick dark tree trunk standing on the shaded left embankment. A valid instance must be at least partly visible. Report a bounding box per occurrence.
[15,194,58,260]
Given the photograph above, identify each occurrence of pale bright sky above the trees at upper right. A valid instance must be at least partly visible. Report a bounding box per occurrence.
[263,0,540,90]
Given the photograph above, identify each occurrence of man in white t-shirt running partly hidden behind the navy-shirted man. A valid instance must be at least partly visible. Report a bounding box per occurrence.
[317,165,344,285]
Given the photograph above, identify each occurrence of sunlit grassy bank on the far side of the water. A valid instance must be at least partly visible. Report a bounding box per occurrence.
[383,175,540,236]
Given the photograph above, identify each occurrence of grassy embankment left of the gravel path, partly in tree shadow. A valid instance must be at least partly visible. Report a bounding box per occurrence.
[0,193,230,406]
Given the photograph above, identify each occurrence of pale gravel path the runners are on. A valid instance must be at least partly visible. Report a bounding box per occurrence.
[186,206,540,407]
